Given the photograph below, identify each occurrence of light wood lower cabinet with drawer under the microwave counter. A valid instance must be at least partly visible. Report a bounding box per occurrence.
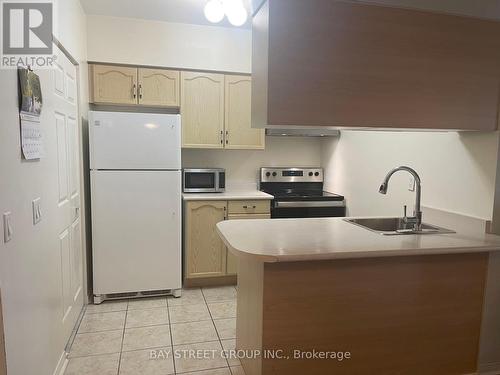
[184,200,271,286]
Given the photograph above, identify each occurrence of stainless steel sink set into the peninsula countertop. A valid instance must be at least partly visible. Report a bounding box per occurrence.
[344,217,455,236]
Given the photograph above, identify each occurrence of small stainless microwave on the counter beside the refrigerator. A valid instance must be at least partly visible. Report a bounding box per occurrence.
[182,168,226,193]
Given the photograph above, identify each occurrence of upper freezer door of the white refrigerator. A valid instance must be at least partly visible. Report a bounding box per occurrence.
[89,111,181,169]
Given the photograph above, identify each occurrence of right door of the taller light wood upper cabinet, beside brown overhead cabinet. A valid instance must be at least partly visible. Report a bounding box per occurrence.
[224,75,265,150]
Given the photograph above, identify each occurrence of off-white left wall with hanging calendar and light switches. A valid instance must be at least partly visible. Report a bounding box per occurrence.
[0,0,87,375]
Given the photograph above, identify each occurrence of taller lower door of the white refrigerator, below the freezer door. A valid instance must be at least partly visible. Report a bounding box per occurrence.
[91,171,181,294]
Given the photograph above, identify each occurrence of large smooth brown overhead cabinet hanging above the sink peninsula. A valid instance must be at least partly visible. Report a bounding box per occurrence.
[252,0,500,130]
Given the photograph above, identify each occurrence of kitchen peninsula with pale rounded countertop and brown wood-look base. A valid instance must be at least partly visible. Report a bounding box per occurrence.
[217,218,500,375]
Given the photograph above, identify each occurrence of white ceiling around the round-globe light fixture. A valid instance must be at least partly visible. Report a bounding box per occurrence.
[80,0,251,28]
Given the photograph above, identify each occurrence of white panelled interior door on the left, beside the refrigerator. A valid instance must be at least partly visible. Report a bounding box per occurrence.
[53,47,83,338]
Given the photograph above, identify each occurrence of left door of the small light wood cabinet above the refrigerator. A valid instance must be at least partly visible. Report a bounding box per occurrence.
[91,65,137,104]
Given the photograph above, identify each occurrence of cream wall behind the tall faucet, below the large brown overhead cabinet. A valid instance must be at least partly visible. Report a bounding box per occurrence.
[322,131,498,219]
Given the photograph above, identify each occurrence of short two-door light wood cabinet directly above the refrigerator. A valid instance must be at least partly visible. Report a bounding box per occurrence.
[90,64,180,107]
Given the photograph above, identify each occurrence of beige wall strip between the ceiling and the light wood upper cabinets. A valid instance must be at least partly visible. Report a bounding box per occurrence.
[88,16,252,73]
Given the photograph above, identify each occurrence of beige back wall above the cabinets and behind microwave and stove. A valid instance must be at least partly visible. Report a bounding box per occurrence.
[87,16,321,186]
